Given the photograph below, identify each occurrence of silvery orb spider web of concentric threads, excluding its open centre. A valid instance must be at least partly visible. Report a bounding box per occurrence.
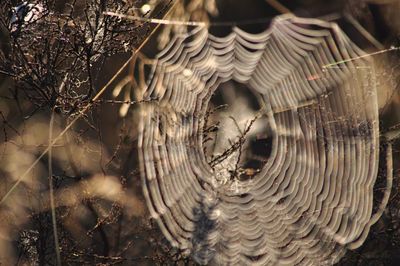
[138,15,390,265]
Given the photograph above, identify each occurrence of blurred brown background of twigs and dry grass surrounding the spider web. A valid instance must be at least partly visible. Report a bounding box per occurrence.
[0,0,400,265]
